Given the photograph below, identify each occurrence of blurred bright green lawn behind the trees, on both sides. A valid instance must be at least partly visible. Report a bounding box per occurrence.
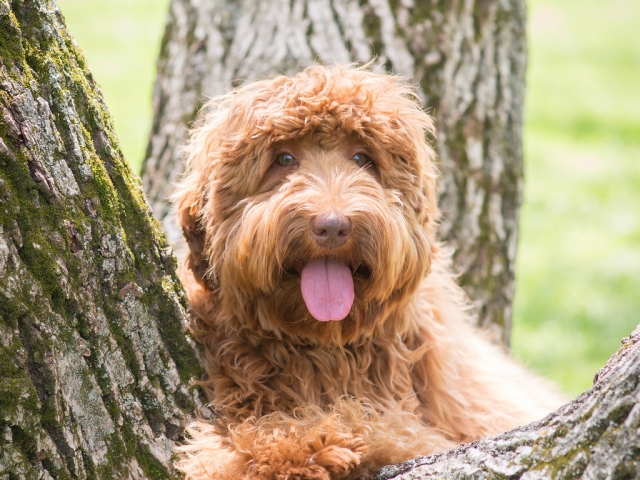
[58,0,640,397]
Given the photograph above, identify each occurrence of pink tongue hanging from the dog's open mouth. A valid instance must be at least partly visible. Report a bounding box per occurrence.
[300,258,354,322]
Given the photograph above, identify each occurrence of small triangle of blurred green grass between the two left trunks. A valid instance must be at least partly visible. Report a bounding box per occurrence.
[57,0,169,172]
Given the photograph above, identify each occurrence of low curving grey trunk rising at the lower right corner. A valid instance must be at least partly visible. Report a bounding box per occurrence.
[376,326,640,480]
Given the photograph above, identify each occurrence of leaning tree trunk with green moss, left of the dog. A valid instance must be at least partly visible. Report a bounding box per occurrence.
[0,0,210,479]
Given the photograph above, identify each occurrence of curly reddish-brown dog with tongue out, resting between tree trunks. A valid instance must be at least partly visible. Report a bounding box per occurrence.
[176,66,560,480]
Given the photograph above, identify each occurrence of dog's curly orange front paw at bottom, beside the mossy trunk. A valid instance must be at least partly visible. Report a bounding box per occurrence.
[172,415,367,480]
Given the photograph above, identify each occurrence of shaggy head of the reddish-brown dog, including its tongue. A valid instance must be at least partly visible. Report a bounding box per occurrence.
[175,66,437,343]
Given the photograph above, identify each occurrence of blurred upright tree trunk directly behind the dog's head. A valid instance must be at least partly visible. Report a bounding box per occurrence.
[143,0,526,343]
